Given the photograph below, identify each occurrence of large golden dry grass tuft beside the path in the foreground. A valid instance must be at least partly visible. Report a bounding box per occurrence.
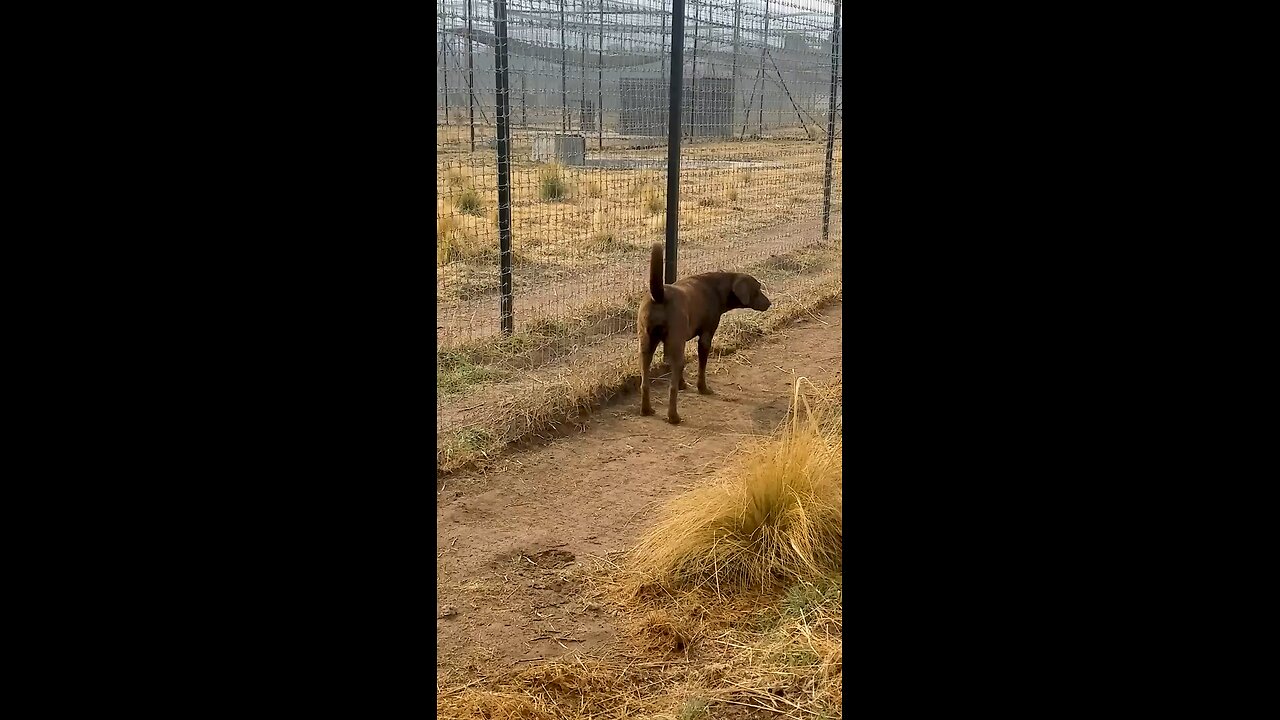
[632,379,844,592]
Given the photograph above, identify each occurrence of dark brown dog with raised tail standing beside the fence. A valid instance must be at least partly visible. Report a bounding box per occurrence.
[636,243,771,425]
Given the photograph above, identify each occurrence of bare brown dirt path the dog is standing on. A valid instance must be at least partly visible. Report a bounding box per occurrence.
[435,301,844,684]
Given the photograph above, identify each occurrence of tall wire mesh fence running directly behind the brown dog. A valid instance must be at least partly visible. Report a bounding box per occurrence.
[436,0,842,456]
